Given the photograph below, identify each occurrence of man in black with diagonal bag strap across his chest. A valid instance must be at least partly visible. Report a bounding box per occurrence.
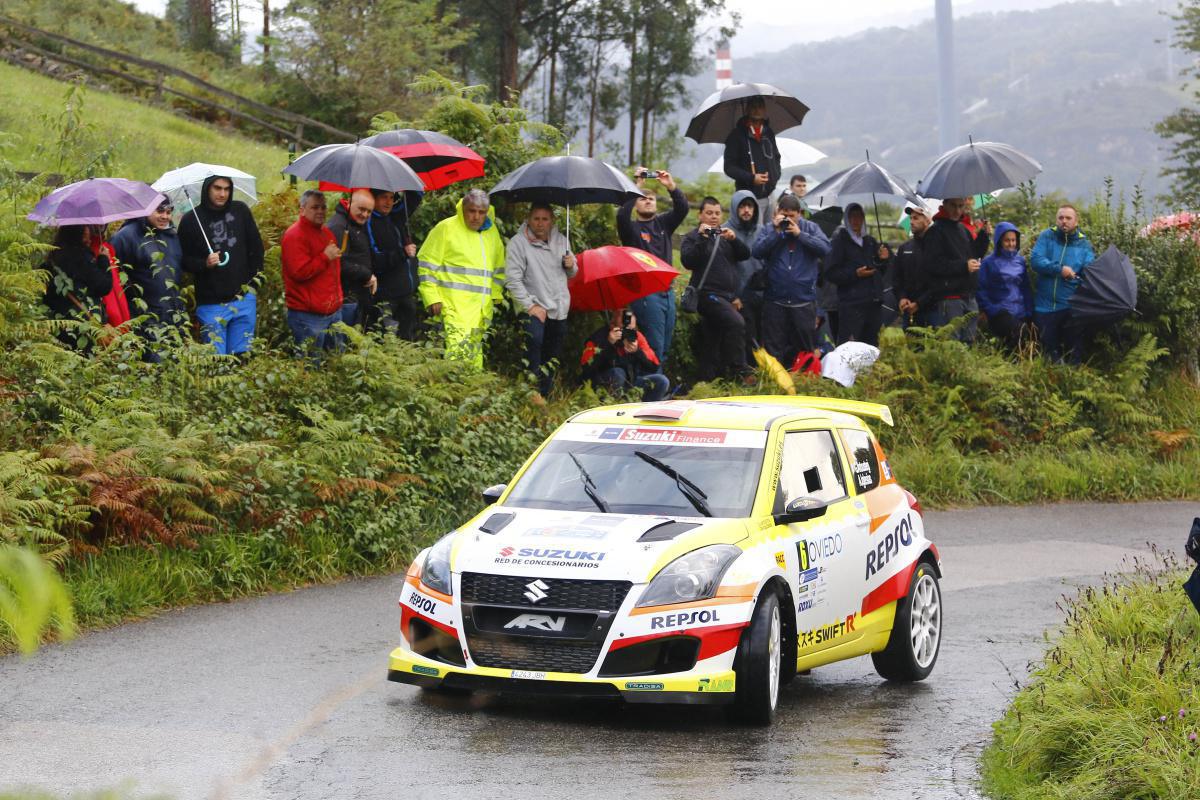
[679,197,752,380]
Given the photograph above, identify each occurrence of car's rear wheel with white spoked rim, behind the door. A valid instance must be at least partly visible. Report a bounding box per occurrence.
[871,561,942,682]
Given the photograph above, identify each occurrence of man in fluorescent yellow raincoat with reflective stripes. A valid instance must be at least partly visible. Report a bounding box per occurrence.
[416,188,504,369]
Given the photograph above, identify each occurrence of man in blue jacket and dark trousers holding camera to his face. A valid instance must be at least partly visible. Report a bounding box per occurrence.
[751,194,829,367]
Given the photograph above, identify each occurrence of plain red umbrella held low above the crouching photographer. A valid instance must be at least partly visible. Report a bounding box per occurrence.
[568,245,679,311]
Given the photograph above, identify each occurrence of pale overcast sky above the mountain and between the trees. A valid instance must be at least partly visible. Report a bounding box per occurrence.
[133,0,1142,60]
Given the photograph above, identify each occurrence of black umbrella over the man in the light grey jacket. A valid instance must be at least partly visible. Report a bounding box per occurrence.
[488,156,642,239]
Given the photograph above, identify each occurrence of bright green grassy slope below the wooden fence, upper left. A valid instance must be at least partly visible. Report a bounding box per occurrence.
[0,64,288,190]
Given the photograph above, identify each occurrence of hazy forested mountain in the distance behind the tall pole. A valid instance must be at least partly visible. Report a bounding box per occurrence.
[672,2,1186,197]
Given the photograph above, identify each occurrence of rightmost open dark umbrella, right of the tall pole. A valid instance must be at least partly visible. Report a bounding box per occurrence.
[917,140,1042,198]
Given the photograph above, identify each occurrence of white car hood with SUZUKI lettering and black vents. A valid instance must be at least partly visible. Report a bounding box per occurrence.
[450,506,746,583]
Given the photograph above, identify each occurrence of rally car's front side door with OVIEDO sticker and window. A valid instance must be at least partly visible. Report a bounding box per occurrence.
[773,428,870,655]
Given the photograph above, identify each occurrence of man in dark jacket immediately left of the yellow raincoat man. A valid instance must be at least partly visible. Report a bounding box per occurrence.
[366,190,421,342]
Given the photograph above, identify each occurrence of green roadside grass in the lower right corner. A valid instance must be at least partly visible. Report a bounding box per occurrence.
[983,559,1200,800]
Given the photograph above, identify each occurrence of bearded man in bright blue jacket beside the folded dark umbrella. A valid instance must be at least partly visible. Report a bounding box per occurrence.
[1030,205,1096,363]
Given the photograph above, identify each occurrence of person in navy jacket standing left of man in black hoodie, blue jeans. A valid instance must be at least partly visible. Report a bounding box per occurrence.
[109,197,187,362]
